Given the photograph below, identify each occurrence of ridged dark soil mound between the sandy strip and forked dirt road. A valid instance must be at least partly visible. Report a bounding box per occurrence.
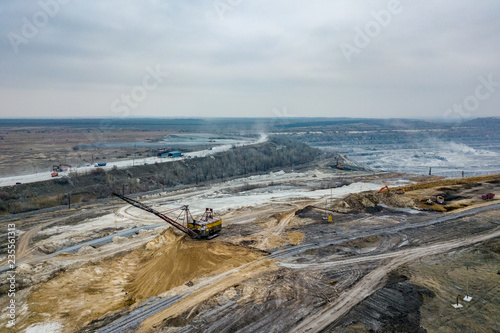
[161,269,334,333]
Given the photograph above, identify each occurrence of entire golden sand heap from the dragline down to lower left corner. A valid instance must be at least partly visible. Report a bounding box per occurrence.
[20,228,263,332]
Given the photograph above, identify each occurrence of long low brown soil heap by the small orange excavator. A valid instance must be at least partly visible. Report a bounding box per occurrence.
[332,192,417,213]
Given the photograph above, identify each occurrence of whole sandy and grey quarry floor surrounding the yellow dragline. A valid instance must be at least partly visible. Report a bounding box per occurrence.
[0,169,500,332]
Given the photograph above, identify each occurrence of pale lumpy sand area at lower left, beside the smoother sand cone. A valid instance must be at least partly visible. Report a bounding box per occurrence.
[24,251,139,332]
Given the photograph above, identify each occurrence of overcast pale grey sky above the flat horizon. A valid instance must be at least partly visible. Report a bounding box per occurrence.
[0,0,500,118]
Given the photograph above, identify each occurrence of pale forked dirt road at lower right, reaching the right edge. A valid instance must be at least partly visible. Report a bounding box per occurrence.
[291,228,500,333]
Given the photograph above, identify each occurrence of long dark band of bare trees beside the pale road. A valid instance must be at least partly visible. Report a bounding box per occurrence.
[0,138,322,214]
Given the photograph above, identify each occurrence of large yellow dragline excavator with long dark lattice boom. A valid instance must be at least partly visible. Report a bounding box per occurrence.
[113,192,222,239]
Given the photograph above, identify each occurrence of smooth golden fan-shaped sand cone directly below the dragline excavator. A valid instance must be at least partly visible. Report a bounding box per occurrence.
[127,228,263,300]
